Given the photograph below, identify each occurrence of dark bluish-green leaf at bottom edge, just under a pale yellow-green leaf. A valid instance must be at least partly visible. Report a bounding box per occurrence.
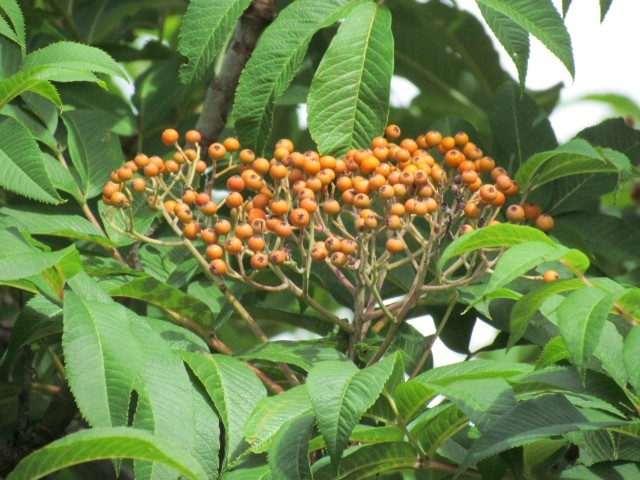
[269,413,315,480]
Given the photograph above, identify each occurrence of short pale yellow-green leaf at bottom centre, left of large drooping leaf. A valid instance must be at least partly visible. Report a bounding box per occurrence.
[244,384,312,453]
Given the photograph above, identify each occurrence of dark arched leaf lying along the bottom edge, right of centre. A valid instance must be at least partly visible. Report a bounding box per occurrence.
[313,442,419,480]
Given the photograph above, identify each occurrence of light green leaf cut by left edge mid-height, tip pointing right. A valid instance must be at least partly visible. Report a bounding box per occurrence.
[0,228,75,281]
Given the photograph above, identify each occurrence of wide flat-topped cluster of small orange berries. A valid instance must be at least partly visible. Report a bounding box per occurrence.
[103,125,553,278]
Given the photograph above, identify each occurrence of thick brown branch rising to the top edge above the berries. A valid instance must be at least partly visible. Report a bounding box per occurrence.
[196,0,275,145]
